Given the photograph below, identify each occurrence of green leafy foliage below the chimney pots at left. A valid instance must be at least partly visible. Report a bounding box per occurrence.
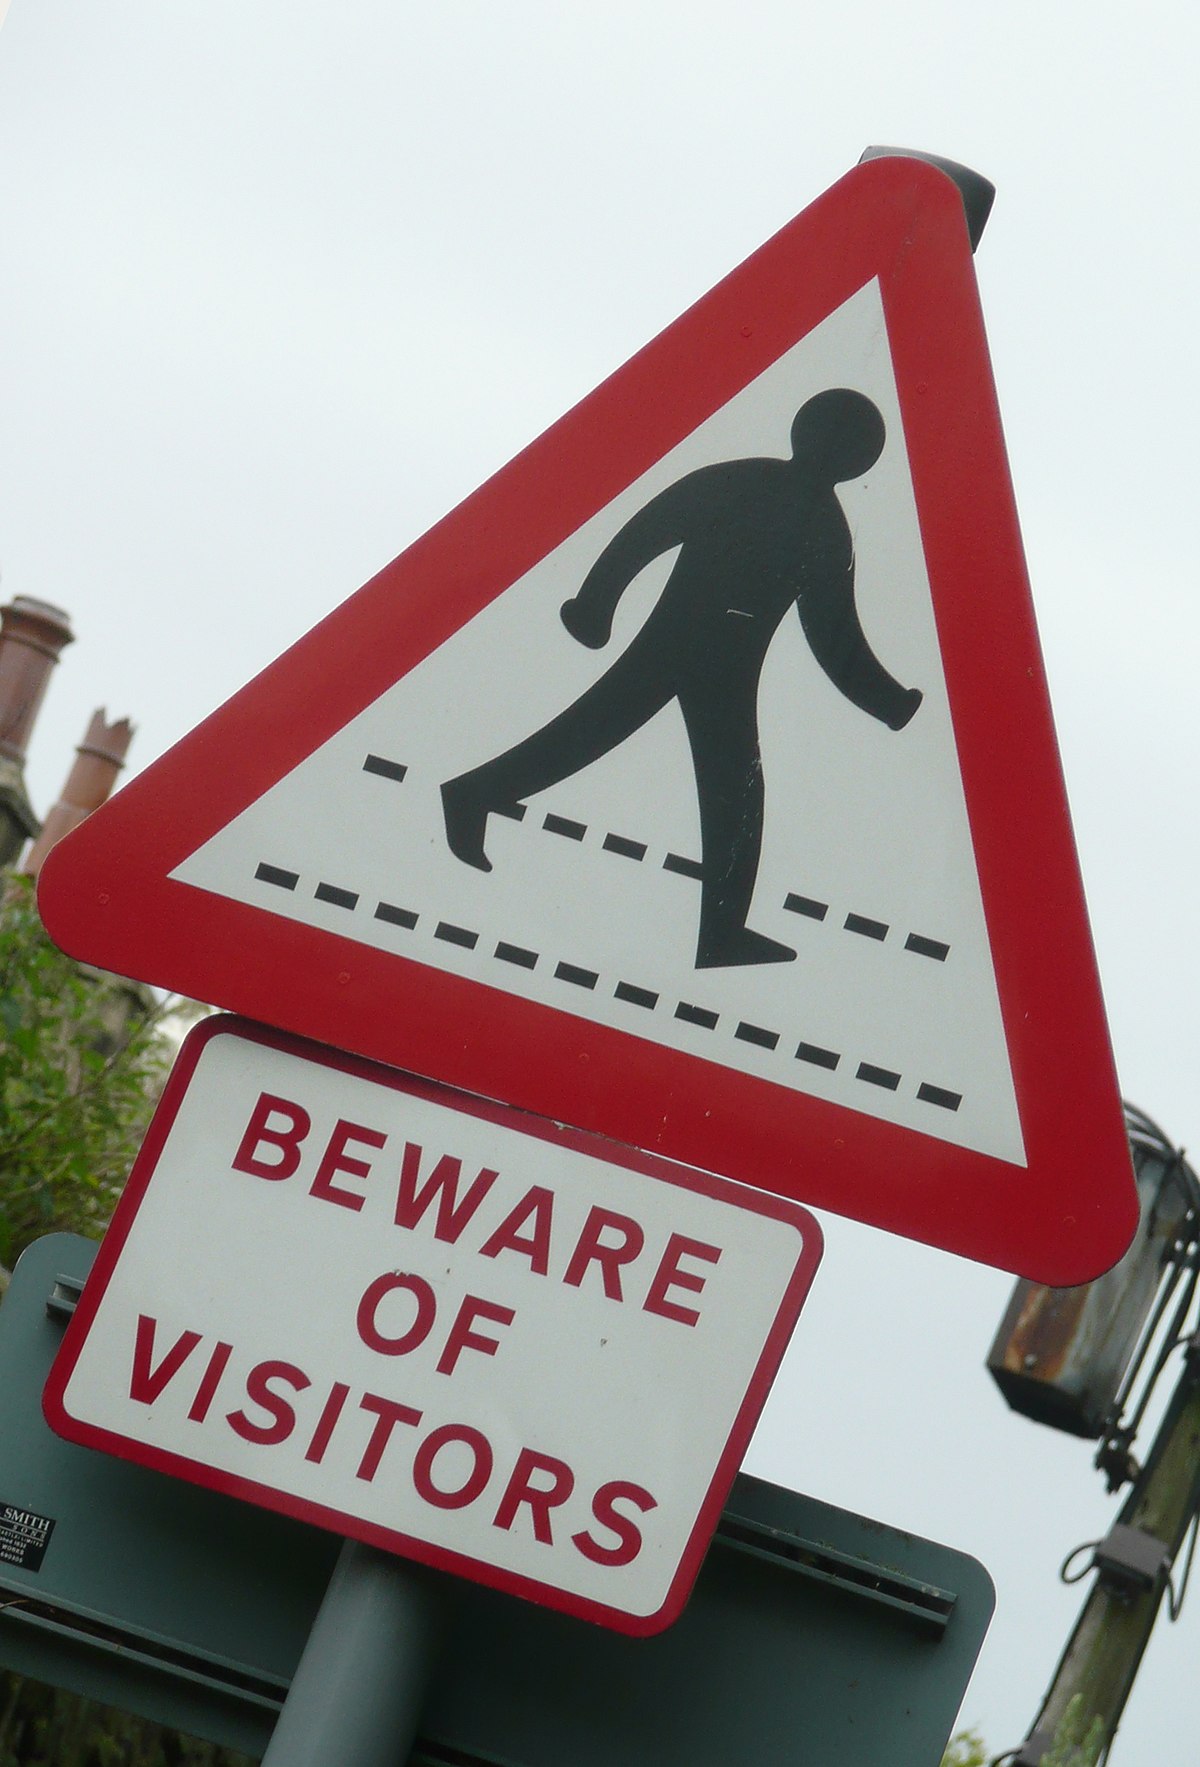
[0,875,180,1265]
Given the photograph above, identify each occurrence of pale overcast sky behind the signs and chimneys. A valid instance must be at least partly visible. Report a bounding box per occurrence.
[0,0,1200,1767]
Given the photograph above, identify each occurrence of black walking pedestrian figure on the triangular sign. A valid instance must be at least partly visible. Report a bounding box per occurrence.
[442,387,921,968]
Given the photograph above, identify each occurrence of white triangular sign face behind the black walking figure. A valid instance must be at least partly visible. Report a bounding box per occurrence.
[173,279,1025,1166]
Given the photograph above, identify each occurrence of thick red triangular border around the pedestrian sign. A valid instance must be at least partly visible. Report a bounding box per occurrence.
[39,157,1136,1285]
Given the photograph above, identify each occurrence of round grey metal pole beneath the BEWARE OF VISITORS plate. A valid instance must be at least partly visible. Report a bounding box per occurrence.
[263,1541,447,1767]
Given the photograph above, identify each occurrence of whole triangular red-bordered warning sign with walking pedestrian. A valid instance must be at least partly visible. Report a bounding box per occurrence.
[41,159,1133,1283]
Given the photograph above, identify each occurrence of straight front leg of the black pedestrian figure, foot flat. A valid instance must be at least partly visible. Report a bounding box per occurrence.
[680,694,795,970]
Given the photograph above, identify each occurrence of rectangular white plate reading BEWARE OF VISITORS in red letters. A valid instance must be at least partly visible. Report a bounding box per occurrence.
[46,1020,820,1633]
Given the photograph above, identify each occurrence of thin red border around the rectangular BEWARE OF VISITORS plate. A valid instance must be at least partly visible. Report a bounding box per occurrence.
[42,1014,824,1638]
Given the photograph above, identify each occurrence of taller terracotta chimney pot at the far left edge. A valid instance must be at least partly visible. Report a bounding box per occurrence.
[0,595,72,866]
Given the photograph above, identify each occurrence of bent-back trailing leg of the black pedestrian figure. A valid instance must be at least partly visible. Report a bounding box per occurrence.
[442,638,675,871]
